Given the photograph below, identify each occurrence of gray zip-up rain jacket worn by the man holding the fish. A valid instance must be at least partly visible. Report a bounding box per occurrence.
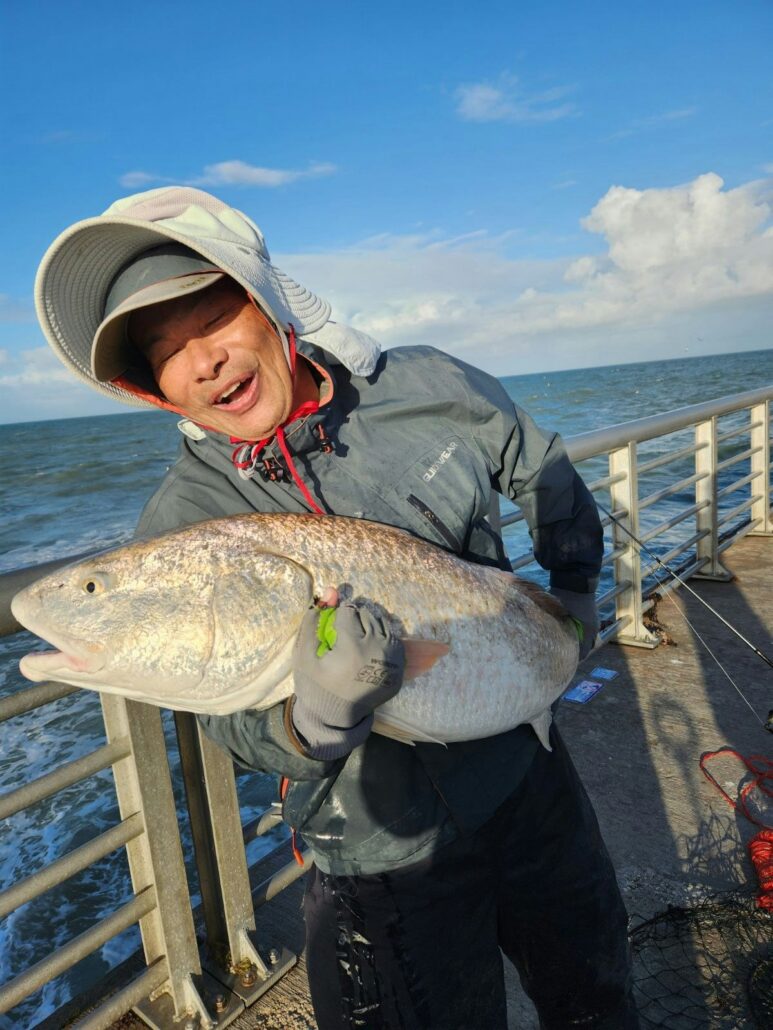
[138,345,603,874]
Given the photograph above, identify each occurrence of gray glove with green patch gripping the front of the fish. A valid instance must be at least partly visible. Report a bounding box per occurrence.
[285,604,405,761]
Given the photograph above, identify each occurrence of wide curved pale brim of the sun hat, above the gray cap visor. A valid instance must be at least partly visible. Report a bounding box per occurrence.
[35,215,330,408]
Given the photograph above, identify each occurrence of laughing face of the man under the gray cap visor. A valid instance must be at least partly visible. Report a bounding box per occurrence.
[129,278,293,440]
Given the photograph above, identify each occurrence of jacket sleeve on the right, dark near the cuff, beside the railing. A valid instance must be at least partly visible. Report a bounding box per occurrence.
[459,356,604,593]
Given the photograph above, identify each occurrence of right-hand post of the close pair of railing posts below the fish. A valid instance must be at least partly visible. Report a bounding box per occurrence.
[174,712,297,1005]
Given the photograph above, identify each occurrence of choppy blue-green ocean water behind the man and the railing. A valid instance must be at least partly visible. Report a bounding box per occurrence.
[0,350,773,1030]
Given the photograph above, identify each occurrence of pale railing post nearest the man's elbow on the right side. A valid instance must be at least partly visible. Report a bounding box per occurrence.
[609,442,660,648]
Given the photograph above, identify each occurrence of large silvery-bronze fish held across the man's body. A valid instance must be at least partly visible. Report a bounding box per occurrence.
[11,514,578,747]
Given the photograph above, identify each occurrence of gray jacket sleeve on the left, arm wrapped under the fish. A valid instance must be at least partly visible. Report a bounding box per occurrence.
[136,451,340,780]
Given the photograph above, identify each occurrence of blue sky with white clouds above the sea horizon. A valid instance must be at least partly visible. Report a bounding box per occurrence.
[0,0,773,421]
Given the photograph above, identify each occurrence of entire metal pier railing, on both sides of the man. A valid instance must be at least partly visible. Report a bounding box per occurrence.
[0,387,773,1030]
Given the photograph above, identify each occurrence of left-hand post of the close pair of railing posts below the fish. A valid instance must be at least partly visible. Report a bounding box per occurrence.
[100,694,213,1027]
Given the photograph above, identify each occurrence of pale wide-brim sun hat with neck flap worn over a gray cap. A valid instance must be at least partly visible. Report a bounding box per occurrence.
[35,186,380,408]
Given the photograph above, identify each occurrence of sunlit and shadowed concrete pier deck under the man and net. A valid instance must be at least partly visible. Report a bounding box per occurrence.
[110,537,773,1030]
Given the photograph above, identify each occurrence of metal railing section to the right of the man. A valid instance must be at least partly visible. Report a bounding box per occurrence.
[500,386,773,647]
